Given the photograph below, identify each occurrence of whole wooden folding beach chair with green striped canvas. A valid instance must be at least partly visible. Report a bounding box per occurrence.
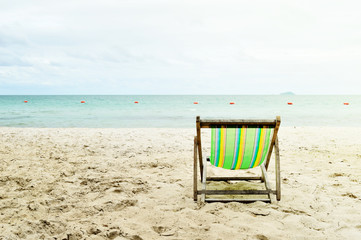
[193,116,281,202]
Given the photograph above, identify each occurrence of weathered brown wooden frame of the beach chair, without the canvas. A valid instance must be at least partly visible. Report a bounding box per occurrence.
[193,116,281,202]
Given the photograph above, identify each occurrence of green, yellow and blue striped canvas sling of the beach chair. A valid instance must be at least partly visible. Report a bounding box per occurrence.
[210,126,273,170]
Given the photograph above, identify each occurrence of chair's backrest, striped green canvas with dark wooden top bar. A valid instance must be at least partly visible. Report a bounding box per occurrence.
[197,117,281,170]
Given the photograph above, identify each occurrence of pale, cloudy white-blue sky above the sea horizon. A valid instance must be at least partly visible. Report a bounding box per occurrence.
[0,0,361,95]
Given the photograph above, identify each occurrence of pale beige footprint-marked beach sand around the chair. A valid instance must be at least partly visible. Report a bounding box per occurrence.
[0,127,361,240]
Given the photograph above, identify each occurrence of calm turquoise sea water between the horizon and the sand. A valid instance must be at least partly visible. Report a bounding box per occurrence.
[0,95,361,128]
